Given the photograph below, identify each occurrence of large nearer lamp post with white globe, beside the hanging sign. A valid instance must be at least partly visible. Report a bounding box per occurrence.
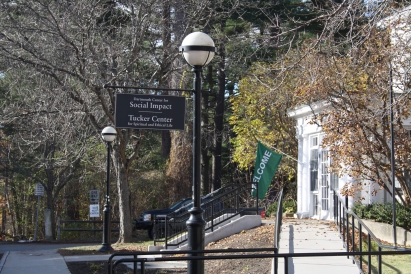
[179,32,216,274]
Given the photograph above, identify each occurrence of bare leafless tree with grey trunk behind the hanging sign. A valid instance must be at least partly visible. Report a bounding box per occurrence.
[0,0,217,242]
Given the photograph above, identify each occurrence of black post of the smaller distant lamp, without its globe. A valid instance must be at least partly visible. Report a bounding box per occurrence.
[98,142,113,252]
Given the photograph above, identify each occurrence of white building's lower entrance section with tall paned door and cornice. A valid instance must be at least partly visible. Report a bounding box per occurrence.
[288,102,390,219]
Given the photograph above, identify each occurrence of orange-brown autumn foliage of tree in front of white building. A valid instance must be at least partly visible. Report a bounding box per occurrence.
[296,30,411,204]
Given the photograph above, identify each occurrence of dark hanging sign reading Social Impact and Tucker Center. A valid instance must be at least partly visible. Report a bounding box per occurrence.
[115,93,186,130]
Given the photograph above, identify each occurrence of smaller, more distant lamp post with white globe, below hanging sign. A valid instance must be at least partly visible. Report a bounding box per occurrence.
[98,127,117,252]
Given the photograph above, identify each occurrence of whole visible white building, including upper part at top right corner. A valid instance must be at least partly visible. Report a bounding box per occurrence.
[288,6,411,219]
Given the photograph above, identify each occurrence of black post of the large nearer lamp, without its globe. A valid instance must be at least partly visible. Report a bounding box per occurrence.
[187,66,205,274]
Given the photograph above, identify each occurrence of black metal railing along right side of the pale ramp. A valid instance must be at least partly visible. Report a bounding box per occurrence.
[333,191,411,274]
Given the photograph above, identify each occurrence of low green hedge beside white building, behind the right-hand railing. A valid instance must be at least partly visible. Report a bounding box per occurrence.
[353,203,411,229]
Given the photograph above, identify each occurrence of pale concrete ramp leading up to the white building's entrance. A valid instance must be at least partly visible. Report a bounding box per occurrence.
[278,219,360,274]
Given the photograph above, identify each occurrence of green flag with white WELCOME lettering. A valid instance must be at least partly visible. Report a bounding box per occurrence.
[251,142,282,199]
